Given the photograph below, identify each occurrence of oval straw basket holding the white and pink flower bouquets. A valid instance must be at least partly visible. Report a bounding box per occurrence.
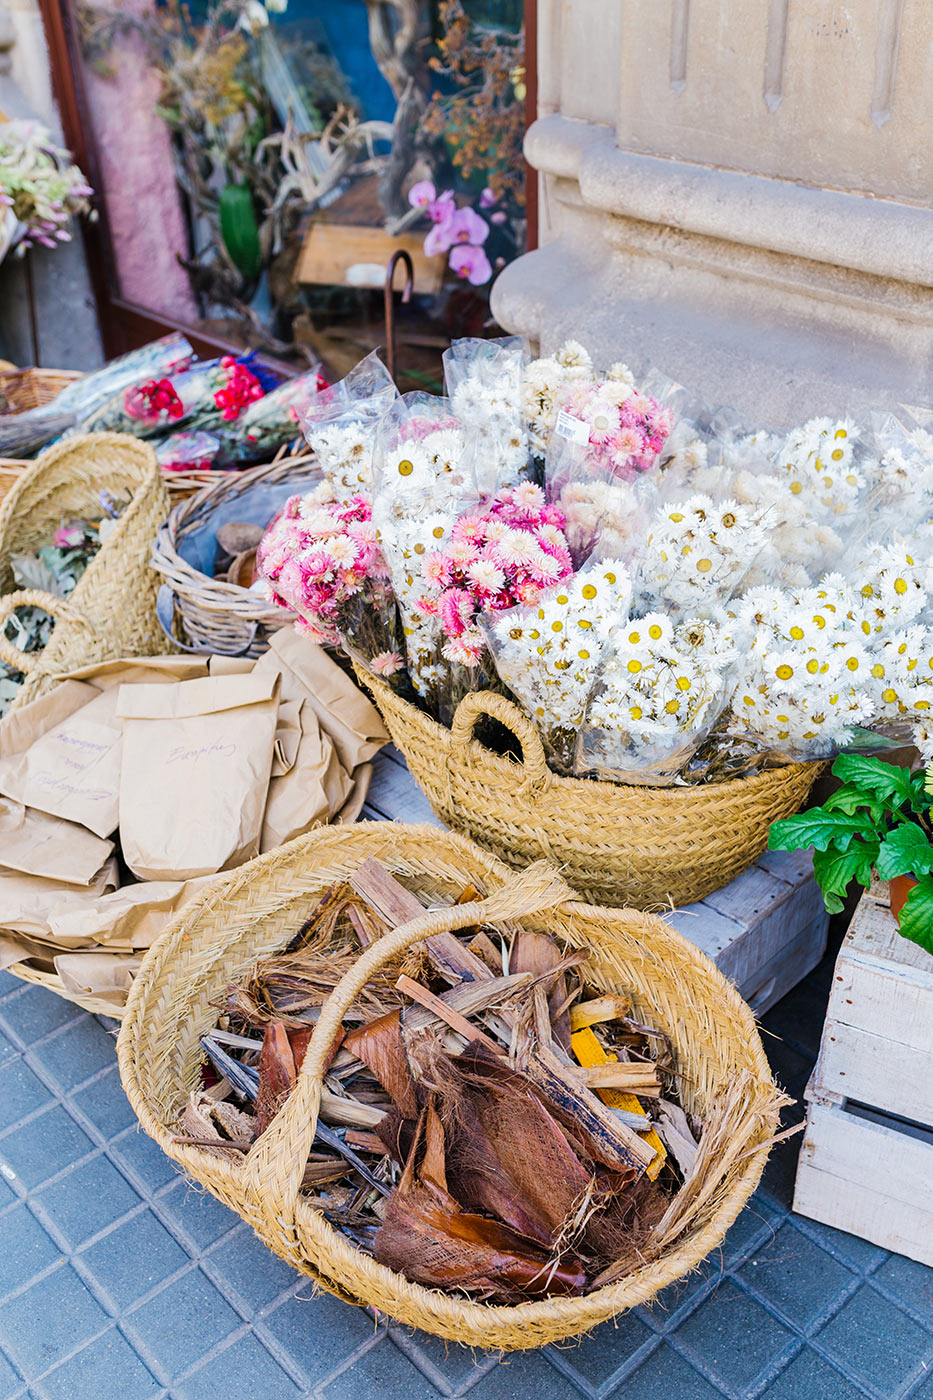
[357,668,820,909]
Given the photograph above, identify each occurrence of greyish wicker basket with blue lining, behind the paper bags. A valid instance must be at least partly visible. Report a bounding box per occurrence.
[153,456,321,657]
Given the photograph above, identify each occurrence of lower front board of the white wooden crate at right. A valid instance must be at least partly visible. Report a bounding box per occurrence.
[794,1082,933,1264]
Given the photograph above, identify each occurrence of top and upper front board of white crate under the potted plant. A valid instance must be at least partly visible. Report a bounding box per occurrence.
[814,886,933,1127]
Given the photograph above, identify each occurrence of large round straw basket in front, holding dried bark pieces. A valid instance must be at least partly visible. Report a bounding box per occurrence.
[118,822,786,1350]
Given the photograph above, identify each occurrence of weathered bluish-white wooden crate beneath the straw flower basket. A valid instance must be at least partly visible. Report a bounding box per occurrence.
[363,746,828,1015]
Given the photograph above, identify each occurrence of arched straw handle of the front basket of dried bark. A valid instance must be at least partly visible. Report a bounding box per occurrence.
[244,861,579,1247]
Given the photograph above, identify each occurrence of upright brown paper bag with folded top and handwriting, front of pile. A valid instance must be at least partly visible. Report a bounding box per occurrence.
[119,672,279,879]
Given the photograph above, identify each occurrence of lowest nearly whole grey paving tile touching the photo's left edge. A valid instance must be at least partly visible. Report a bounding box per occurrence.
[0,1264,109,1380]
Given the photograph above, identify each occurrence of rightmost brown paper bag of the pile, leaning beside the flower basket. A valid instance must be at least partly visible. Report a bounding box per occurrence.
[254,627,389,773]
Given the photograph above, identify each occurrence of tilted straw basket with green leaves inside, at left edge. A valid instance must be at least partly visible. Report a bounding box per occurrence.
[0,433,177,706]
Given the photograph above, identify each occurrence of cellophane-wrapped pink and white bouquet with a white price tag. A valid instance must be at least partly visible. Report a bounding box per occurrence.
[545,363,674,567]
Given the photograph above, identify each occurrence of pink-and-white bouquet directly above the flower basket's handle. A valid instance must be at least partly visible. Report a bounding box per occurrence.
[419,482,573,724]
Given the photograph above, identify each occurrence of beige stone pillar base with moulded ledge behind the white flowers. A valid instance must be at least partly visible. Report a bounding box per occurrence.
[493,0,933,426]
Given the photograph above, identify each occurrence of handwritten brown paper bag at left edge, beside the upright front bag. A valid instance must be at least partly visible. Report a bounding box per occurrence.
[0,686,122,836]
